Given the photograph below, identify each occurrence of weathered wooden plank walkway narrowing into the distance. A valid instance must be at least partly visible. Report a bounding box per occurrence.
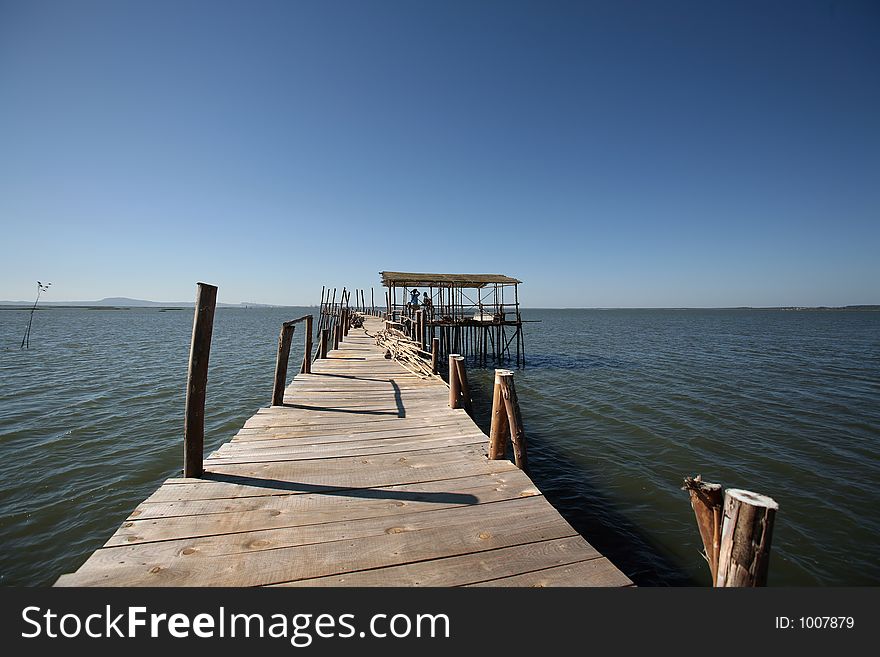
[56,318,632,586]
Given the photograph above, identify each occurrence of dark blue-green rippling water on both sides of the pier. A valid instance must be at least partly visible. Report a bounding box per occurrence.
[0,308,880,585]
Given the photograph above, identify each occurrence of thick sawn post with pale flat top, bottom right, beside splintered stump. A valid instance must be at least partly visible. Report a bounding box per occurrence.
[715,488,779,587]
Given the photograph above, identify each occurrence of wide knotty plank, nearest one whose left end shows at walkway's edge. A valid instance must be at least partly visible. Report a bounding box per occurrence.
[56,498,574,586]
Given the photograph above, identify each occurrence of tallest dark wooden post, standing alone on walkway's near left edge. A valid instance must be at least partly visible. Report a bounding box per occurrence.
[183,283,217,477]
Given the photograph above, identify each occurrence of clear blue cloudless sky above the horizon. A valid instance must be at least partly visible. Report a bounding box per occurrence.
[0,0,880,307]
